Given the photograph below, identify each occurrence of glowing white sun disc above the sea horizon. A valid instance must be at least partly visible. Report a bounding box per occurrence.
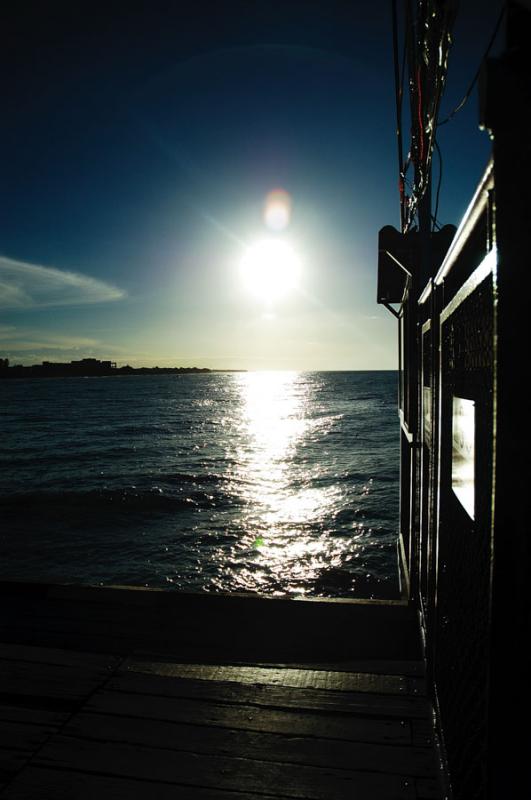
[240,239,301,303]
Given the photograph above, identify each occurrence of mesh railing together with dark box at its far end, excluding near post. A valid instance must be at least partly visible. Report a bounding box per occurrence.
[379,163,498,800]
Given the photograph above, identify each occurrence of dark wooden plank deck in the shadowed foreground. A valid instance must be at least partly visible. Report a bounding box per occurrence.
[0,584,445,800]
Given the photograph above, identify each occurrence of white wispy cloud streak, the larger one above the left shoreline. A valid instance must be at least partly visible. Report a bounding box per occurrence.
[0,256,125,309]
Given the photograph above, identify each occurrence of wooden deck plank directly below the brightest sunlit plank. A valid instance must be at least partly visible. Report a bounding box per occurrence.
[105,672,431,720]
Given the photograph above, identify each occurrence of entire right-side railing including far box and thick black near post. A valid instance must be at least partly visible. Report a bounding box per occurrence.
[378,3,531,800]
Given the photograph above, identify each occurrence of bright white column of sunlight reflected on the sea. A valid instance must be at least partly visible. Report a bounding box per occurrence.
[222,372,368,594]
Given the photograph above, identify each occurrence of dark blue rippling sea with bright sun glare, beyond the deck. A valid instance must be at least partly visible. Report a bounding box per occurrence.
[0,372,398,597]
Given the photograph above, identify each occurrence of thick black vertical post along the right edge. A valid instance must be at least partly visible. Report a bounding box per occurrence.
[483,3,531,800]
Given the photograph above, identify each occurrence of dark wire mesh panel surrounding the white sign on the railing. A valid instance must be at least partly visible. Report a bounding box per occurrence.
[434,277,494,800]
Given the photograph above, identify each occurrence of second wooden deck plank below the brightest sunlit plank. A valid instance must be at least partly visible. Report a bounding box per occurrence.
[84,690,411,745]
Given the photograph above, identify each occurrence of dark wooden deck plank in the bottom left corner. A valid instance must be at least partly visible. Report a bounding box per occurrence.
[2,766,281,800]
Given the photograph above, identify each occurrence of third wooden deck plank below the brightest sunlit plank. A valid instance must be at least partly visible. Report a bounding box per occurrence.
[62,713,437,778]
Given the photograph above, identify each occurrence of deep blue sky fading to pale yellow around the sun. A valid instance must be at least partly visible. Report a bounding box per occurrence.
[0,0,508,370]
